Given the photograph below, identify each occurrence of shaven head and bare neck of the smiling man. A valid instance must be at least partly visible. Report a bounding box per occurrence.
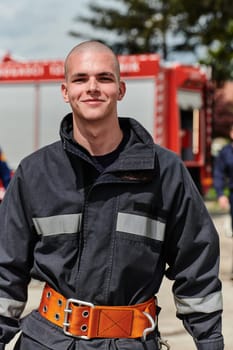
[62,42,125,155]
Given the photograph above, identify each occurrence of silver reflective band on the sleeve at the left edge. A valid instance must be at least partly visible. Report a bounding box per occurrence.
[0,298,26,318]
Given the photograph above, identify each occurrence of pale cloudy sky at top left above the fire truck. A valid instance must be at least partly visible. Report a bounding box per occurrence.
[0,0,89,60]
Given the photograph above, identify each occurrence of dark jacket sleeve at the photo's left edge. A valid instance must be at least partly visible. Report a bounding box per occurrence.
[0,167,34,349]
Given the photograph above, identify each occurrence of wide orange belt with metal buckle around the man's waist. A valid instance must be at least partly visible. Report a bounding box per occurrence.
[39,285,156,339]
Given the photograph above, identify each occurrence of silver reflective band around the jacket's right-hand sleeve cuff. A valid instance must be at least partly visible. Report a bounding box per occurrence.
[175,292,223,315]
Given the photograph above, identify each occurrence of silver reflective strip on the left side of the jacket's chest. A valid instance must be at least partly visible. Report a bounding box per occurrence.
[33,213,82,236]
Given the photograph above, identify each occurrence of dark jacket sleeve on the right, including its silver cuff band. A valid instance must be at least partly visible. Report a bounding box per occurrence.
[165,159,223,350]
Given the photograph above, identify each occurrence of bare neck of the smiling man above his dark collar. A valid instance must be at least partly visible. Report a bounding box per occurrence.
[73,118,123,156]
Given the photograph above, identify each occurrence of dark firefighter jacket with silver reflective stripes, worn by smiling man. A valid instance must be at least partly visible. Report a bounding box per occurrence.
[0,114,223,350]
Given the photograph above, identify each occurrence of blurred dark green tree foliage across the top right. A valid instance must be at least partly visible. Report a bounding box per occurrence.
[69,0,233,85]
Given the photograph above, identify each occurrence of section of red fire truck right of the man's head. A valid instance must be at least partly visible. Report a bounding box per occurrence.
[119,55,213,194]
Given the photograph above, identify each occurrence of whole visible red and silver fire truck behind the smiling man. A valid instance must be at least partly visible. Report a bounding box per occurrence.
[0,54,212,193]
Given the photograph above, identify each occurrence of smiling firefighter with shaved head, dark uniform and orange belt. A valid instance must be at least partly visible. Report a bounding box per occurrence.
[0,41,223,350]
